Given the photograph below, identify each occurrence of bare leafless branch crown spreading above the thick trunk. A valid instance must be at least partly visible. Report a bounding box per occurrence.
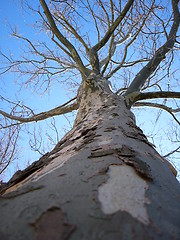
[0,0,180,176]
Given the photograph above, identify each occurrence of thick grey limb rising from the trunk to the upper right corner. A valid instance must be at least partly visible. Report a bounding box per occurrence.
[125,0,180,95]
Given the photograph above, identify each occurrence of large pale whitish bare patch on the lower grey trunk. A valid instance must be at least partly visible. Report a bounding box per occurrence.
[98,165,150,225]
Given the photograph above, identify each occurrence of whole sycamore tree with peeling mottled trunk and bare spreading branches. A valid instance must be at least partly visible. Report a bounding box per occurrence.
[0,0,180,240]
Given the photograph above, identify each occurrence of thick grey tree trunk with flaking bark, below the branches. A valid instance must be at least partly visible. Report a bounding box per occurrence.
[0,81,180,240]
